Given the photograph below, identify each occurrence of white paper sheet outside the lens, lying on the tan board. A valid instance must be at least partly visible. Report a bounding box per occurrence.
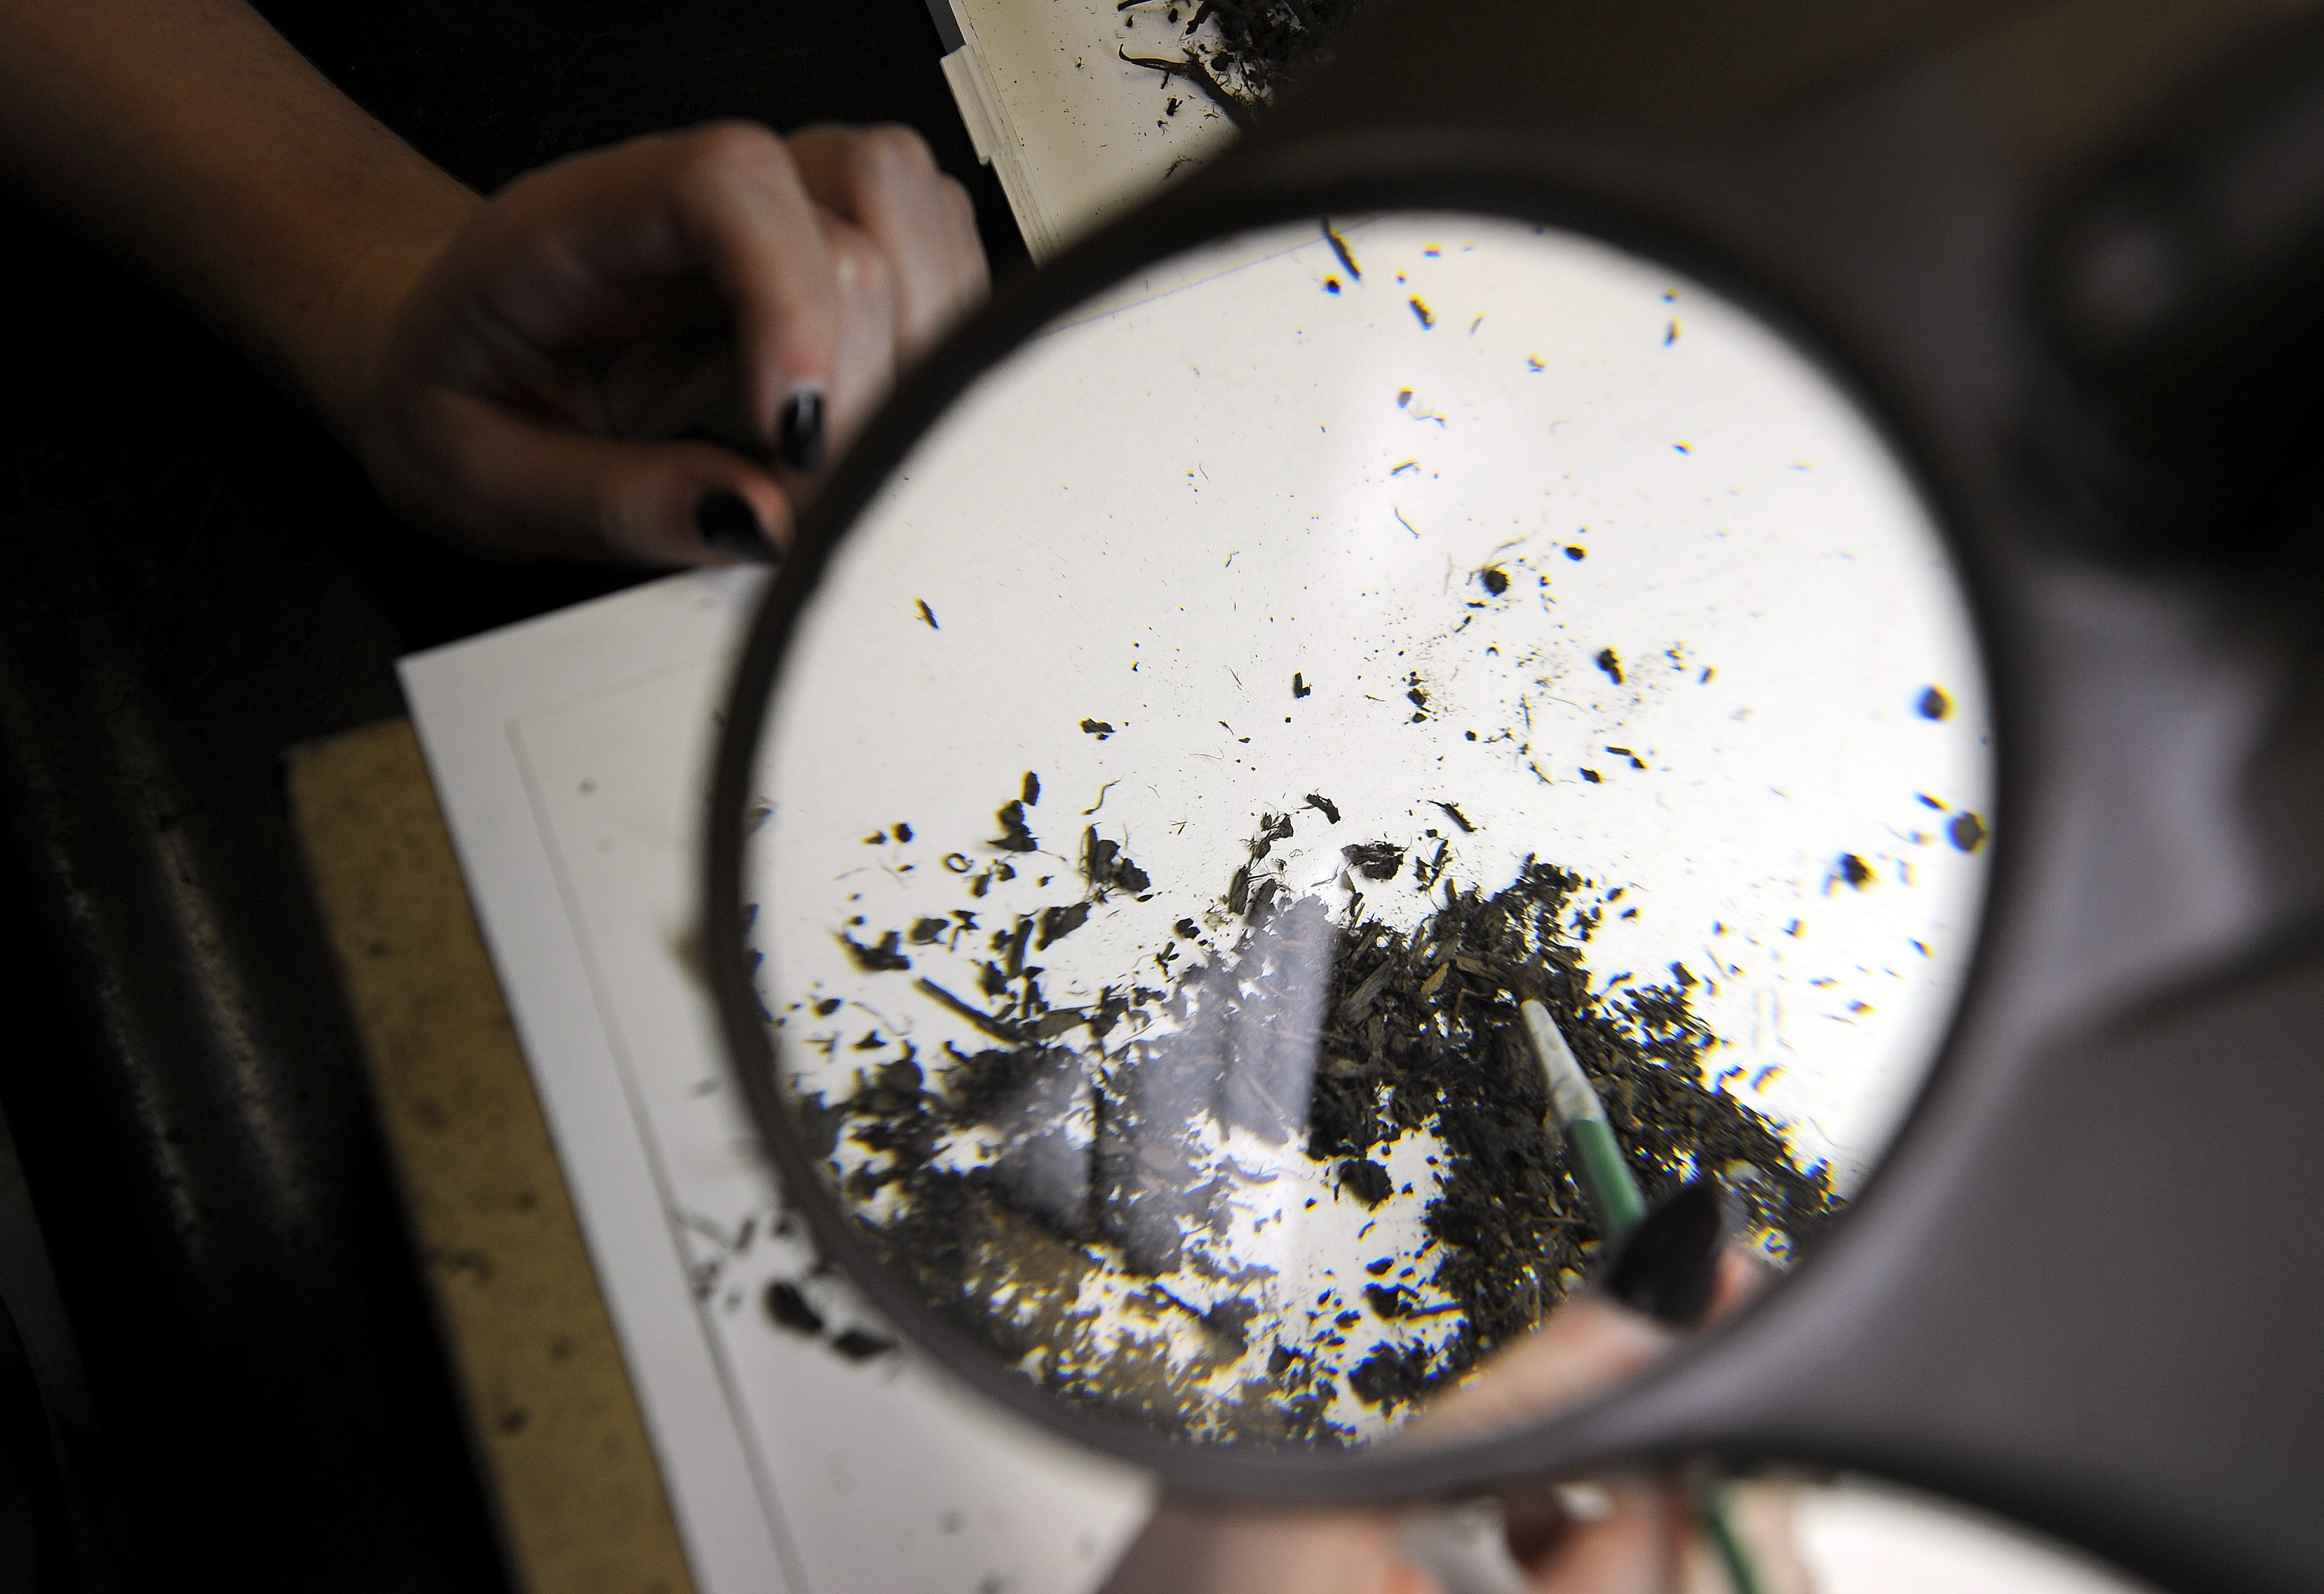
[402,572,1150,1594]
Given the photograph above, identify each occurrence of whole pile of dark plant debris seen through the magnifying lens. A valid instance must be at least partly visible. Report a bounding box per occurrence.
[783,776,1838,1448]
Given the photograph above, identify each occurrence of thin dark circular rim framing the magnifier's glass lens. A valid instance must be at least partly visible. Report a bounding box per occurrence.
[704,137,2017,1504]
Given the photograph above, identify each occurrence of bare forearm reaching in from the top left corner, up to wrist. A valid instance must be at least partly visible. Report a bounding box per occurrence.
[0,0,477,437]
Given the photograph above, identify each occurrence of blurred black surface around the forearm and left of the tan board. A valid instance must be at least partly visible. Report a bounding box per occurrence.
[0,0,1022,1589]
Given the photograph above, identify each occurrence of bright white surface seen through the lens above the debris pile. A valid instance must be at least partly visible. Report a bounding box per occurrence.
[755,218,1992,1190]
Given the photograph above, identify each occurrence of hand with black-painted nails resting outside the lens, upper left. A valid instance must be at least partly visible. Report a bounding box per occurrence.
[337,123,988,565]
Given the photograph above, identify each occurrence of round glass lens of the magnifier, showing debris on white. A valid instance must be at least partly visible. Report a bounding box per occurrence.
[744,214,1992,1450]
